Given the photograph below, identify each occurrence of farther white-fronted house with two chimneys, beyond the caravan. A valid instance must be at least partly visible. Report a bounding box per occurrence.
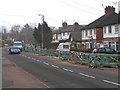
[52,22,83,43]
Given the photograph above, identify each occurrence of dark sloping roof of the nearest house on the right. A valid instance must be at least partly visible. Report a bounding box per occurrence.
[81,12,118,30]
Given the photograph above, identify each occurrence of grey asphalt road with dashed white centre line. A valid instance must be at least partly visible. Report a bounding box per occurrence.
[2,49,120,88]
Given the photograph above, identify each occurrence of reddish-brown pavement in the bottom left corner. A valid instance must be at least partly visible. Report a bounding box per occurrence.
[2,57,48,88]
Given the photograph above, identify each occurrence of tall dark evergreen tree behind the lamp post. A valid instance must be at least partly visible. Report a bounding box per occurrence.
[33,22,52,48]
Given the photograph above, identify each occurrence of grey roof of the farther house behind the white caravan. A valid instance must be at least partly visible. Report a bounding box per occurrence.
[53,25,83,33]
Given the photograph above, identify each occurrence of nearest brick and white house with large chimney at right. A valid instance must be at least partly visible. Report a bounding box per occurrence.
[81,6,120,50]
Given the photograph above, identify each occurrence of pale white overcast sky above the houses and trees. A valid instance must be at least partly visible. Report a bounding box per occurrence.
[0,0,120,29]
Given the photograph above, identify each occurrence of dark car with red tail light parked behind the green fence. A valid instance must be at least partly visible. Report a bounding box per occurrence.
[92,47,116,54]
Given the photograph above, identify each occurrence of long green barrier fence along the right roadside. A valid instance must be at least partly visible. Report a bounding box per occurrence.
[25,47,120,68]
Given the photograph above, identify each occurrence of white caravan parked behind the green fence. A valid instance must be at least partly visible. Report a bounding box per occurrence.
[56,42,71,51]
